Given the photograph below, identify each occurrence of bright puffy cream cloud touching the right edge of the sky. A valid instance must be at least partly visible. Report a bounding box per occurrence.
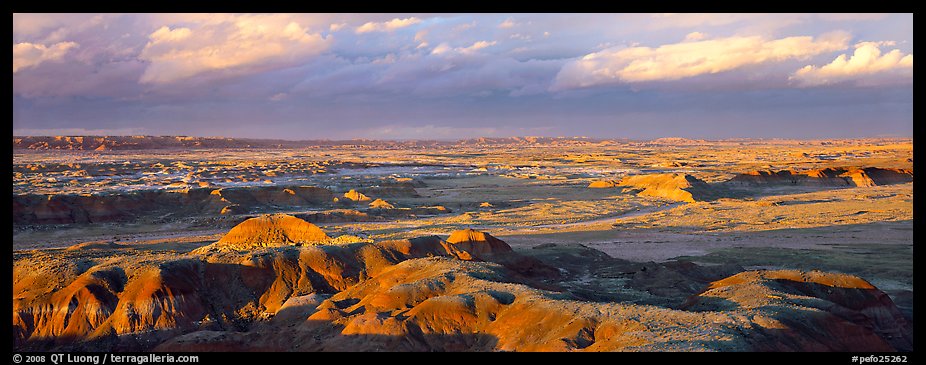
[790,42,913,86]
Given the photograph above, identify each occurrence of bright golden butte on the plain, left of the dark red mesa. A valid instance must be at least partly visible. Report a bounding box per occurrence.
[618,173,713,203]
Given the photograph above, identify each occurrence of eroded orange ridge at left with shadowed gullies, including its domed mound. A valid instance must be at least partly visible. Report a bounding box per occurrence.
[13,228,556,349]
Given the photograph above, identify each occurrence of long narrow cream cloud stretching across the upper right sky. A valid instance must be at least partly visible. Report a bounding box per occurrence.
[554,32,849,89]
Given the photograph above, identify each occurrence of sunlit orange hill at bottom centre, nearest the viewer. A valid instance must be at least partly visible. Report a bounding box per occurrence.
[156,257,742,351]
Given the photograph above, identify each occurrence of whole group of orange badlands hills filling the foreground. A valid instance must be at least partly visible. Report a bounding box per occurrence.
[13,215,912,352]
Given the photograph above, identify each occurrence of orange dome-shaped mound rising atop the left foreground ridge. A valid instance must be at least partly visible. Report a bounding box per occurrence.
[214,214,331,250]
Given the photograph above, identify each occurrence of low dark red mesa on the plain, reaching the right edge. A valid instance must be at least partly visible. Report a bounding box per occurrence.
[728,167,913,187]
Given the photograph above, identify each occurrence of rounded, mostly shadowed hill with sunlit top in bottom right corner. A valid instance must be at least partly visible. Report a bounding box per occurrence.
[683,270,913,351]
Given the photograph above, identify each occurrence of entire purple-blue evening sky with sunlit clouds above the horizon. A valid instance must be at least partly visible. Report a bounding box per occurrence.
[13,13,913,140]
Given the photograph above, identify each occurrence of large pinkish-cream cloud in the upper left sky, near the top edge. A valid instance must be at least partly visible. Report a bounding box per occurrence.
[138,15,330,84]
